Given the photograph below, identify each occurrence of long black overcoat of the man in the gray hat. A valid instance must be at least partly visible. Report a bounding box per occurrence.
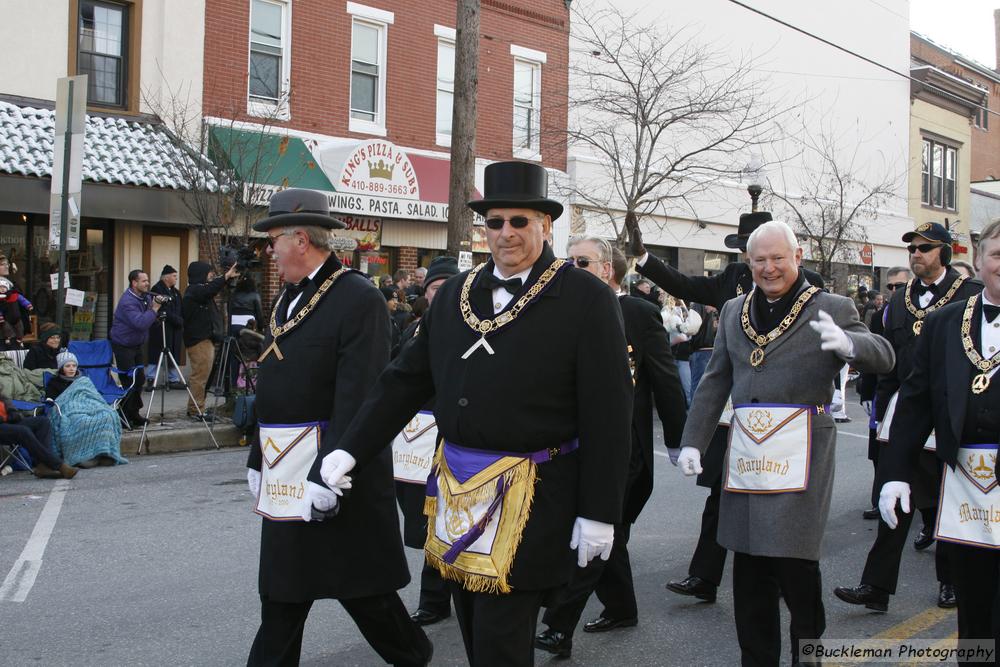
[247,255,408,602]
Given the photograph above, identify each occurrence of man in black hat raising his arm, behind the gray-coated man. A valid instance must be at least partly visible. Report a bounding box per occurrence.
[629,211,824,602]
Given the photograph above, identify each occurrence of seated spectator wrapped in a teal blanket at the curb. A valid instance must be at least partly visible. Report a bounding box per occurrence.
[49,374,128,468]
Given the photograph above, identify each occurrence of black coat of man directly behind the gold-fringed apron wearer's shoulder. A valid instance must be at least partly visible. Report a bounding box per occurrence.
[619,296,687,523]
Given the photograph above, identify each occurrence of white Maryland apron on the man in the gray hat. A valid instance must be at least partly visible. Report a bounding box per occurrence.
[254,422,327,521]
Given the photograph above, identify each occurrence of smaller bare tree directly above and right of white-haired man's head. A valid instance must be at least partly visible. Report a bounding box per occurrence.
[765,129,902,282]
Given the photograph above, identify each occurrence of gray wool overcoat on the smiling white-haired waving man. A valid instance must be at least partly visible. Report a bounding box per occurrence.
[681,285,895,560]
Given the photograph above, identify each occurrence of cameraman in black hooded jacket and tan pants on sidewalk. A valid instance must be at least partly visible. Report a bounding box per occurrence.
[181,262,240,419]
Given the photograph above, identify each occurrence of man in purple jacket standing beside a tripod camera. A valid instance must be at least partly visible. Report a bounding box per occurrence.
[108,269,162,426]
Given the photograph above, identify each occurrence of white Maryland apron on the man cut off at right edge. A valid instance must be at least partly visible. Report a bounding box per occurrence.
[934,445,1000,549]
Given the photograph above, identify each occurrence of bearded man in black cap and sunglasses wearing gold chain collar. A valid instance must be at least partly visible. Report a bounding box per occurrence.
[834,222,983,612]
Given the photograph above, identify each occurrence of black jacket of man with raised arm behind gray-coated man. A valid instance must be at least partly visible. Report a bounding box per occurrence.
[636,253,826,310]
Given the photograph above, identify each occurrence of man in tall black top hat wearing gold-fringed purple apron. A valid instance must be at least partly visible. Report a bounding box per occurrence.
[323,162,632,667]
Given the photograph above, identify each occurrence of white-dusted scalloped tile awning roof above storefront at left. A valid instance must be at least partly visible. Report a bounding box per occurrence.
[0,100,218,190]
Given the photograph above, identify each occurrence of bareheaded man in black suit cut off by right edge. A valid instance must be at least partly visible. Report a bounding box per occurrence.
[879,221,1000,664]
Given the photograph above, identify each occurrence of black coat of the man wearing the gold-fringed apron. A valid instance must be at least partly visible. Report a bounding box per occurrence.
[341,244,633,590]
